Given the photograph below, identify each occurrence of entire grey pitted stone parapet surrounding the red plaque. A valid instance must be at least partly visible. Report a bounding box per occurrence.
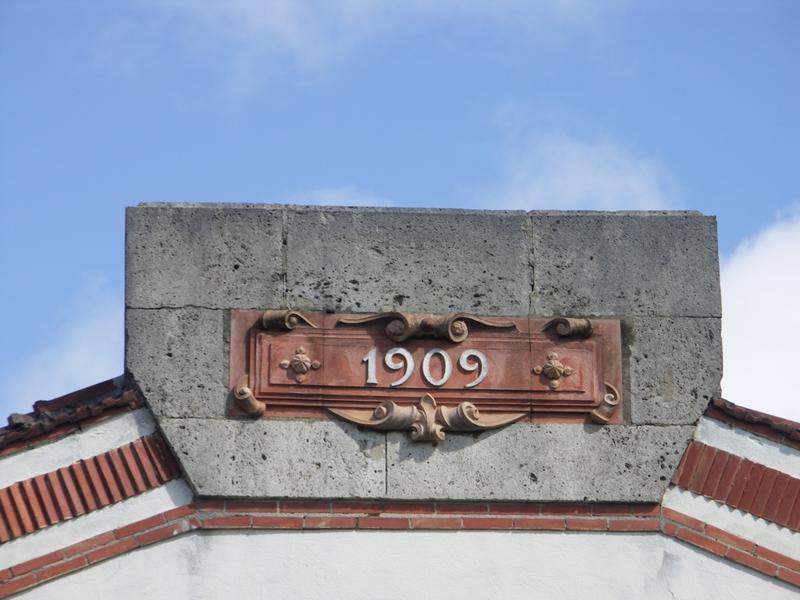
[120,205,721,502]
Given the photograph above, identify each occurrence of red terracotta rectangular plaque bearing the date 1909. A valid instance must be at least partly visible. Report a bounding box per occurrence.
[228,310,622,423]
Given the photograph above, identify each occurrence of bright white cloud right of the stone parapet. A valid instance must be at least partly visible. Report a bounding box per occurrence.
[721,206,800,421]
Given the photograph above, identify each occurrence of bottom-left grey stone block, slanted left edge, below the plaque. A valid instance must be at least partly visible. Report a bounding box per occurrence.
[160,419,386,498]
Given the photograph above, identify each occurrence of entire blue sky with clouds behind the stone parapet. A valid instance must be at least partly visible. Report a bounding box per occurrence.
[0,0,800,420]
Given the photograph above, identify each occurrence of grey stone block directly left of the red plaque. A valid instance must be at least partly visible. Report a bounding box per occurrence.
[125,308,228,418]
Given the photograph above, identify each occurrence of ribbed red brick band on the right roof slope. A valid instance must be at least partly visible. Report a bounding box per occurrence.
[672,441,800,531]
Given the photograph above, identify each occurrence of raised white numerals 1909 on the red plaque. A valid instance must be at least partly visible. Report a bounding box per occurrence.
[361,347,489,388]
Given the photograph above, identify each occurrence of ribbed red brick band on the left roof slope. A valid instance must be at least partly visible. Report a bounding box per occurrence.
[0,434,178,543]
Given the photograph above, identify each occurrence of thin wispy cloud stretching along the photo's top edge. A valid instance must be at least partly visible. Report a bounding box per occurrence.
[96,0,630,95]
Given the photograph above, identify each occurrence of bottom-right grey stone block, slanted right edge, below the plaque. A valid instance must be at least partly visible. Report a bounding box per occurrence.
[386,423,694,502]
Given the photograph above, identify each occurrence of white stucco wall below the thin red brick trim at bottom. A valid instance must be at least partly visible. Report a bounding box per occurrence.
[21,531,797,600]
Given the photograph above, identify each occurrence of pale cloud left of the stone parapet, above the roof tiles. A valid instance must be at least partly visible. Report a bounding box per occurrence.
[0,282,124,415]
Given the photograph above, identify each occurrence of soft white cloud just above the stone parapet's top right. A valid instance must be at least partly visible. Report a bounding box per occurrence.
[494,135,678,210]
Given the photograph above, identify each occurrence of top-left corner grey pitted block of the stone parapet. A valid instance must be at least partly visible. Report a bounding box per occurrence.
[125,205,285,308]
